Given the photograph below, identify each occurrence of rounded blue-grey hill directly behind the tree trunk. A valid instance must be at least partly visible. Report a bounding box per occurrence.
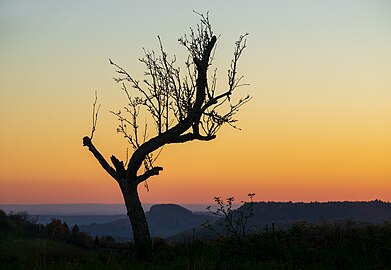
[80,204,218,241]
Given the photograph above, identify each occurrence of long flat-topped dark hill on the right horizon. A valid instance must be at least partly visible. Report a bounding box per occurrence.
[170,200,391,241]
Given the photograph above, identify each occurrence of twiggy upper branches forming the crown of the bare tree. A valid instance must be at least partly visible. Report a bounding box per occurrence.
[110,14,250,149]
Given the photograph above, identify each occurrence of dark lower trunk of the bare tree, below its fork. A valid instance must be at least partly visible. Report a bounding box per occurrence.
[121,186,152,260]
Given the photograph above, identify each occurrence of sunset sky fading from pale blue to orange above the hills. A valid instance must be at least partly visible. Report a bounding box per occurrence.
[0,0,391,204]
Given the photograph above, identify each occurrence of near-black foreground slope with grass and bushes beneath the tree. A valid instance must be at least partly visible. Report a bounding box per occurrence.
[0,211,391,269]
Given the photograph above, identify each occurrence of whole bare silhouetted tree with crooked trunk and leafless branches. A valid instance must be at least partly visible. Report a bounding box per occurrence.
[83,14,250,258]
